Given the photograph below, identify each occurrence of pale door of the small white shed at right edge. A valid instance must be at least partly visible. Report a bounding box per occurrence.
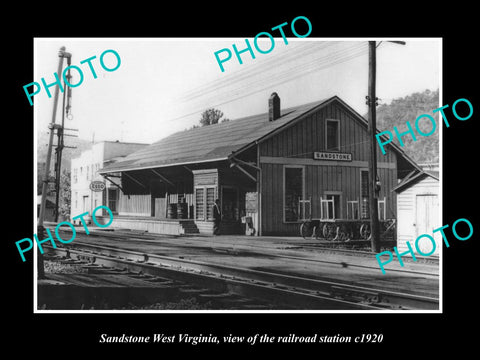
[415,195,442,255]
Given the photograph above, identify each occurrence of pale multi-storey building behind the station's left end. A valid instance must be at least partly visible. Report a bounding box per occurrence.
[70,141,147,224]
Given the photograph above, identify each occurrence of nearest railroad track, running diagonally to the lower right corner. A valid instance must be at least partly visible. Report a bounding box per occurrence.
[43,240,439,310]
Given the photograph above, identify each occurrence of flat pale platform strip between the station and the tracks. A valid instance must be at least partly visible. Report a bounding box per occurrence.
[95,229,441,275]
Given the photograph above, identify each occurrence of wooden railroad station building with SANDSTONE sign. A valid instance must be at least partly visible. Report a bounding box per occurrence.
[99,93,421,236]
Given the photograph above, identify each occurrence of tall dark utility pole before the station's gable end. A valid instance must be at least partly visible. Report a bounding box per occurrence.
[367,41,380,253]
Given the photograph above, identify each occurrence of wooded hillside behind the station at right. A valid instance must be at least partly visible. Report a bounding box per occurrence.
[377,89,441,164]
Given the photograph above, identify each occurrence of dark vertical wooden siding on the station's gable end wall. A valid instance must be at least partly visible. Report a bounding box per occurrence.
[259,102,397,236]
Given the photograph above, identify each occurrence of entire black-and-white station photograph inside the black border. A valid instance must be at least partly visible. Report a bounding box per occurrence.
[31,35,440,312]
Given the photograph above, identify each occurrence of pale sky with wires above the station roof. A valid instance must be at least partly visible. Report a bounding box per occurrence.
[32,37,442,143]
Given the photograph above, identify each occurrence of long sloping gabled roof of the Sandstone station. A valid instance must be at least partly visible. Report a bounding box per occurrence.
[100,96,417,174]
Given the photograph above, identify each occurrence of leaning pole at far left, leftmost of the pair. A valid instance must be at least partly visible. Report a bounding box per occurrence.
[37,46,72,279]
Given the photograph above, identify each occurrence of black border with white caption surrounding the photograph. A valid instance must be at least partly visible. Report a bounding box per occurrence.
[6,3,480,356]
